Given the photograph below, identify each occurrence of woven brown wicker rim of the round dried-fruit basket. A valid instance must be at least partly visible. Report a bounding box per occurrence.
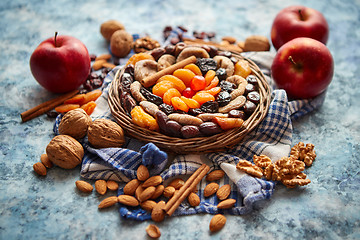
[108,53,271,154]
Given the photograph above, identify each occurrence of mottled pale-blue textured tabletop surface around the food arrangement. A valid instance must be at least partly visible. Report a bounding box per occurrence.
[0,0,360,239]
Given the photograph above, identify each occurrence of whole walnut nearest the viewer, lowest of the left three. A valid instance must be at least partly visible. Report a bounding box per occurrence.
[46,135,84,169]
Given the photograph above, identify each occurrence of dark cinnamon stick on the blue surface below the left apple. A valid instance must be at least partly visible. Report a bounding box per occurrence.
[20,90,79,122]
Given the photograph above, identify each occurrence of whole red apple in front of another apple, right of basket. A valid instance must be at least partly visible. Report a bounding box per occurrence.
[271,38,334,98]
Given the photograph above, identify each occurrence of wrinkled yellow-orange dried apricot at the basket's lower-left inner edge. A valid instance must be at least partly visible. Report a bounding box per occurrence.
[130,106,159,131]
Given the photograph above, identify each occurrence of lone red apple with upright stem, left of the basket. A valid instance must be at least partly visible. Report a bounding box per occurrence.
[30,33,91,93]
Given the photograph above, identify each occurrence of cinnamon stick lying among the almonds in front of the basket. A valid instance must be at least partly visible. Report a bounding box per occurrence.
[164,164,210,216]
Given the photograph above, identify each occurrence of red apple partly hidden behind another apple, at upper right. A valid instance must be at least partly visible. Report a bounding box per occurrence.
[271,6,329,49]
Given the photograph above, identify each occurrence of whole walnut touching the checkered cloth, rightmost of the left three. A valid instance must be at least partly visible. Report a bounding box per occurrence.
[88,119,125,148]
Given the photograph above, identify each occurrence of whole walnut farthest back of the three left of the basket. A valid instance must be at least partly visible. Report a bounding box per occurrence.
[59,108,92,139]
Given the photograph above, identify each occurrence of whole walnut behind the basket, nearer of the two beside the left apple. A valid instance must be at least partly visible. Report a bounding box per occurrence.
[110,30,134,58]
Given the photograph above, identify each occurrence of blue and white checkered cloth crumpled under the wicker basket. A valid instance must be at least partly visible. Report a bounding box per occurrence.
[54,49,325,220]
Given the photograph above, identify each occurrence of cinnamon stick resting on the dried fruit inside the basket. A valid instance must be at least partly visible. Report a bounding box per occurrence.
[141,56,196,87]
